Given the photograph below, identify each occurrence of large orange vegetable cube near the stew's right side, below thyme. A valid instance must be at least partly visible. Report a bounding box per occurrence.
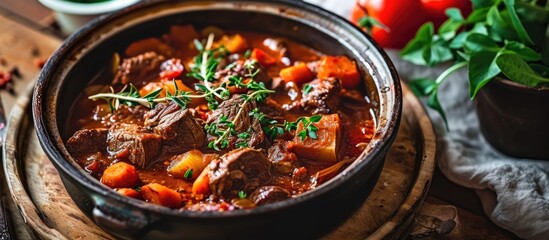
[292,114,341,163]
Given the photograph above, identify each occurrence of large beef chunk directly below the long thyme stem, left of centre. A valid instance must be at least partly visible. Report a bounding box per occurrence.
[145,102,206,154]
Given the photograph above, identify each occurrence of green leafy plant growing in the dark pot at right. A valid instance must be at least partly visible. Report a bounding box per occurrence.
[400,0,549,127]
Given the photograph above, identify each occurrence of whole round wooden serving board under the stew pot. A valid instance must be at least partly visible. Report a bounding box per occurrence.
[5,80,436,239]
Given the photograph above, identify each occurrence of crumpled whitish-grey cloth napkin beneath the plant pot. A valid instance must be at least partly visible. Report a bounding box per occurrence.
[308,0,549,240]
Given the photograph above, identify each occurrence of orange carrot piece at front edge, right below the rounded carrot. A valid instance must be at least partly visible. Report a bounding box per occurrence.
[141,183,182,208]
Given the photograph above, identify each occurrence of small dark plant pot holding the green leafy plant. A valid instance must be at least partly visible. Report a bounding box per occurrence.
[475,78,549,160]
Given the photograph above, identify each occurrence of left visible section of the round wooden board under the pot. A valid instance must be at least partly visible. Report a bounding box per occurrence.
[4,83,113,239]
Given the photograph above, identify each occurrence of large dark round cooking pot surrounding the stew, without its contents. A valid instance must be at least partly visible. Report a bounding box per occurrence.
[32,0,402,239]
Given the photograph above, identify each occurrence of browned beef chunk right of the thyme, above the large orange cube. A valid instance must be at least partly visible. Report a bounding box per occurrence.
[283,78,341,114]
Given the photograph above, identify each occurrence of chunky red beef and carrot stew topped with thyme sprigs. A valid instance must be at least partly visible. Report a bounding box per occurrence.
[66,25,375,211]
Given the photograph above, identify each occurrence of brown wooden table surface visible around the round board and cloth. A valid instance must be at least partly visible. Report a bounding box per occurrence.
[0,0,518,239]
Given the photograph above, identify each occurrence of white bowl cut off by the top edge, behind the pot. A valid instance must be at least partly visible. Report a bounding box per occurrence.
[38,0,140,35]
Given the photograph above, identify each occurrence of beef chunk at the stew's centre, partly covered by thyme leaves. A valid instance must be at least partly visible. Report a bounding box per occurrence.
[206,95,265,149]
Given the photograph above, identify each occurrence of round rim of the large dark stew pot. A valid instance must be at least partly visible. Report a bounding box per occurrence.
[33,0,402,219]
